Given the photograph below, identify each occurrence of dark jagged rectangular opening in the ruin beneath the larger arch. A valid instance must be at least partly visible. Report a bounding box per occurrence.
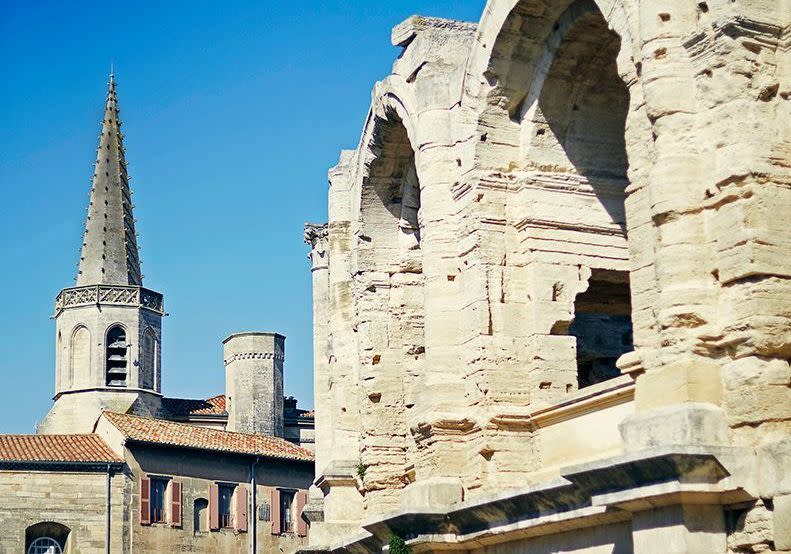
[569,269,633,388]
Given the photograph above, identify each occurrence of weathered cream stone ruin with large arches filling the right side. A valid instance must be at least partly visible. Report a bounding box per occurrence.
[305,0,791,554]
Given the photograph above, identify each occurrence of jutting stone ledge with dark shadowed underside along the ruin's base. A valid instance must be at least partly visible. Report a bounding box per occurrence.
[324,446,752,552]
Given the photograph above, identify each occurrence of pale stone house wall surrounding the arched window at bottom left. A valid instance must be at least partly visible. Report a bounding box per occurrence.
[0,470,131,554]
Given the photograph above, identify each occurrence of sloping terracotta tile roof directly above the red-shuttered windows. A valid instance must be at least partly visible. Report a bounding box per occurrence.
[104,412,313,462]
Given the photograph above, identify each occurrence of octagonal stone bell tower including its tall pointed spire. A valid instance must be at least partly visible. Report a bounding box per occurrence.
[38,74,164,433]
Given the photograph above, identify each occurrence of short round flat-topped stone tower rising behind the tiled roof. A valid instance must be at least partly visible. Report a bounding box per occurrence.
[223,333,286,437]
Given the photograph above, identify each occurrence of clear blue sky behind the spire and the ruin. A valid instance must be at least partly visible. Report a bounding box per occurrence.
[0,0,484,433]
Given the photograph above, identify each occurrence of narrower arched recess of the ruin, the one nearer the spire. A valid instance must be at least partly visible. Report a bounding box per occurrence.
[352,86,425,512]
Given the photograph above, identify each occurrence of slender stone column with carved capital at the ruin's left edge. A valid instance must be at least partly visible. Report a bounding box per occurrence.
[305,223,334,475]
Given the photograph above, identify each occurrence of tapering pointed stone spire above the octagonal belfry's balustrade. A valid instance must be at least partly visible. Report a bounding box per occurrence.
[77,72,143,287]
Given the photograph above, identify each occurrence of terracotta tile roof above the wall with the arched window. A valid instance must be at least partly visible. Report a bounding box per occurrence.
[0,435,124,463]
